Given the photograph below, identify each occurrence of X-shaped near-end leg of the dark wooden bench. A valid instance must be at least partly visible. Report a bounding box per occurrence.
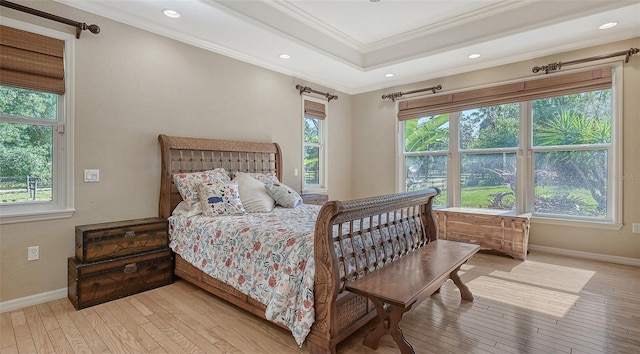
[362,298,415,354]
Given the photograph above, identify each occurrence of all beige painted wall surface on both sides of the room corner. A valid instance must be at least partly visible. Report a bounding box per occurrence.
[0,1,640,302]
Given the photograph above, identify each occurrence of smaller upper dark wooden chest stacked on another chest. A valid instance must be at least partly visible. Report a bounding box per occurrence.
[76,218,168,263]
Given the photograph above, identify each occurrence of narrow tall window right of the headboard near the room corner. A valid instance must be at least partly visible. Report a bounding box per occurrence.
[302,96,327,192]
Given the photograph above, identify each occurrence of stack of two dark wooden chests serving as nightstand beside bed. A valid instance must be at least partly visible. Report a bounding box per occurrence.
[67,218,174,309]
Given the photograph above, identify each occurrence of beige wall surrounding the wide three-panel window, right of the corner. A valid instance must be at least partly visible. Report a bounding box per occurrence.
[352,38,640,258]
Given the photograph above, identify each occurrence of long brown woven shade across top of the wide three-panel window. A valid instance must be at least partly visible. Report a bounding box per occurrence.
[398,68,612,121]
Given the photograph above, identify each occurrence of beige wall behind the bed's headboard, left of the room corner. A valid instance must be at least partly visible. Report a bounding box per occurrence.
[0,1,351,302]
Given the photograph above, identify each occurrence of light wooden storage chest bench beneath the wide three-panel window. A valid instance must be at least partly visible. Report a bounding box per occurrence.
[433,208,531,260]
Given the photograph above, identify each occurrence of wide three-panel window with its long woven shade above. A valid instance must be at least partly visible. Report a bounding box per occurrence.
[398,68,621,224]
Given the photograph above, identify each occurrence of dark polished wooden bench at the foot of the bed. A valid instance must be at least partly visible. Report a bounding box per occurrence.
[346,240,480,354]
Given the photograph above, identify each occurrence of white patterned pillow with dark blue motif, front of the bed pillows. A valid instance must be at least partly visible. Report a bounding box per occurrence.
[198,182,246,216]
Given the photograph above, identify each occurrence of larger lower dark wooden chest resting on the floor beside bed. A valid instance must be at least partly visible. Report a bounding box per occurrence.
[68,248,174,310]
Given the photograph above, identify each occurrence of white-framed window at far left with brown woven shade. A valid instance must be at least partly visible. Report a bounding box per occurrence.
[0,18,73,223]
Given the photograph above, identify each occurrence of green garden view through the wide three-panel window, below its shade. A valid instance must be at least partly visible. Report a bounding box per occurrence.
[403,89,613,220]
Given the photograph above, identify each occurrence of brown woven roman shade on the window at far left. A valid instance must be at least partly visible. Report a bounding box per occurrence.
[0,26,65,95]
